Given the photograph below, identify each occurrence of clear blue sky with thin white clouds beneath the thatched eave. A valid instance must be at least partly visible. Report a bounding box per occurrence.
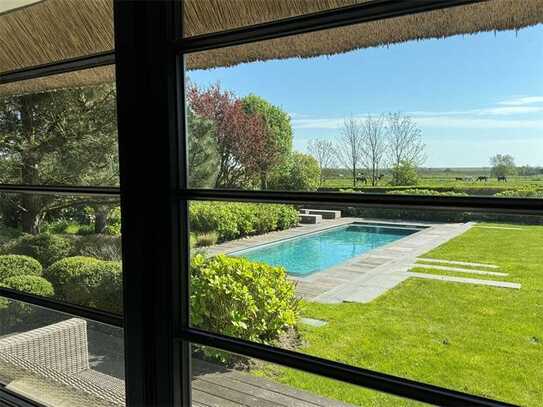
[188,25,543,167]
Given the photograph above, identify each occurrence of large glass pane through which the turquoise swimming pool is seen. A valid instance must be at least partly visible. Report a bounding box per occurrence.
[190,202,543,406]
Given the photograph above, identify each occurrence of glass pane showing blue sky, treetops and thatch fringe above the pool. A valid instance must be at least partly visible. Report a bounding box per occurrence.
[185,1,543,198]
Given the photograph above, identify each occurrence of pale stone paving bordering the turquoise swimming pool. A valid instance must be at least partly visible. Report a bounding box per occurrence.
[202,217,473,303]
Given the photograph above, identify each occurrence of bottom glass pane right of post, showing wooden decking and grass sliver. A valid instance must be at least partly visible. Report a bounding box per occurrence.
[192,345,416,407]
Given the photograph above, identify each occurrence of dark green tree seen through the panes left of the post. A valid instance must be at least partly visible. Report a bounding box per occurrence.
[0,85,118,234]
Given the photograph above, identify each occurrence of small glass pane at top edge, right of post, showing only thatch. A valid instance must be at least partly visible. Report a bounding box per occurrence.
[183,0,368,37]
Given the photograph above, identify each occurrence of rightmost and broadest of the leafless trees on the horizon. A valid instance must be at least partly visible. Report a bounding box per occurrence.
[386,112,426,167]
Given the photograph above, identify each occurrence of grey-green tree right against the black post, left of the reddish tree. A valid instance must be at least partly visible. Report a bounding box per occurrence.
[187,108,219,188]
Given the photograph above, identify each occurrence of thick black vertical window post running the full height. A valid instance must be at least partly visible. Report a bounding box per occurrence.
[114,0,190,406]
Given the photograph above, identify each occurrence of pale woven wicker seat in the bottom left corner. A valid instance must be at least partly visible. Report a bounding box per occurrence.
[0,318,125,407]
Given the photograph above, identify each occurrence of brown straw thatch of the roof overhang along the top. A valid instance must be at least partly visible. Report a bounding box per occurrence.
[0,0,543,94]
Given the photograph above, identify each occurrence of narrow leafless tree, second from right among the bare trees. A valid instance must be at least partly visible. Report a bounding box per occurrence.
[360,116,387,185]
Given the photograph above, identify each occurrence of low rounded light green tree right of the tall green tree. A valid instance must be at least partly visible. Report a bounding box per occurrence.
[270,152,321,191]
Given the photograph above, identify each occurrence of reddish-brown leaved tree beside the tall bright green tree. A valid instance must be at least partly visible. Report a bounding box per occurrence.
[187,85,266,188]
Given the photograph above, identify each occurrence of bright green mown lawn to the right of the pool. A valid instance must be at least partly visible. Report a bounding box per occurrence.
[264,225,543,406]
